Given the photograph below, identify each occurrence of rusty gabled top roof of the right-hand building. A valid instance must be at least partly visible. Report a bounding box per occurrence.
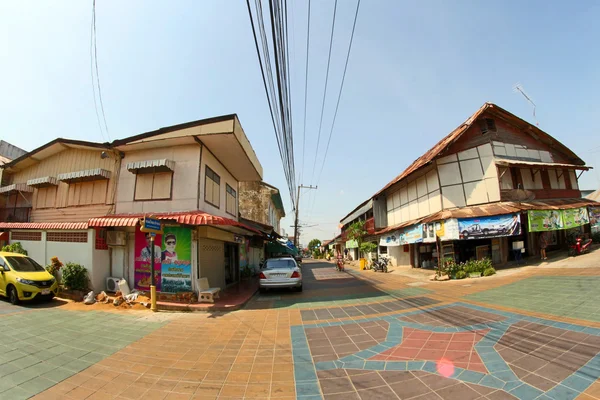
[373,102,585,197]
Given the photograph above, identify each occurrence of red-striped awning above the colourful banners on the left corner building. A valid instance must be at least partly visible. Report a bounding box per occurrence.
[89,211,260,233]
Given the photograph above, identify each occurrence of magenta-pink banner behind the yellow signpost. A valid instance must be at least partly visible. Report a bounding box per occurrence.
[133,229,162,291]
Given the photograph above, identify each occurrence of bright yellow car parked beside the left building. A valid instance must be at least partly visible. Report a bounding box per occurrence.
[0,252,58,304]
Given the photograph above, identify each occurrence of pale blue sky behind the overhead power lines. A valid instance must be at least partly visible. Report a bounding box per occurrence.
[0,0,600,244]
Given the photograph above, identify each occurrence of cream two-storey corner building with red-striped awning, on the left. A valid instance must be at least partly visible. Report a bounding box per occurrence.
[0,115,262,293]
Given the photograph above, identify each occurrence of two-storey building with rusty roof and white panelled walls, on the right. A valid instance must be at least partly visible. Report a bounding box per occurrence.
[373,103,597,268]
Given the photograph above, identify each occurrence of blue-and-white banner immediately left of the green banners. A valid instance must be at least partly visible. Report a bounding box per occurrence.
[458,214,521,239]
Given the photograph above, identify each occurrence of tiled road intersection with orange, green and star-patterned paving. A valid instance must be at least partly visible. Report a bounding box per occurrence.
[0,254,600,400]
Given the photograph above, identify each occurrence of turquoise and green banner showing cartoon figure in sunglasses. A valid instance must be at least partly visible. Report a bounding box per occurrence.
[161,226,192,293]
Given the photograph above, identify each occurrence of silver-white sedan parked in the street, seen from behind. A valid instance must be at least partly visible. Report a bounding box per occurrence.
[259,257,302,292]
